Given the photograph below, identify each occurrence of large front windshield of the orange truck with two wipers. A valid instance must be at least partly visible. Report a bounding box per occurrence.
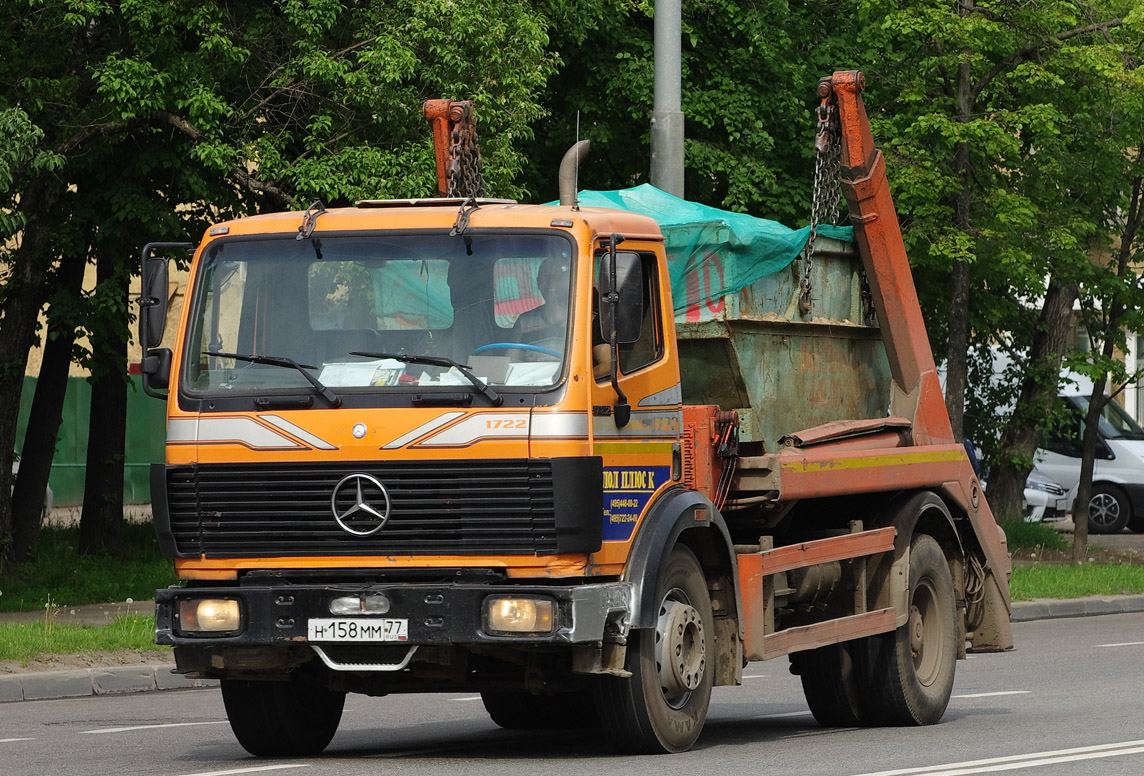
[183,233,573,395]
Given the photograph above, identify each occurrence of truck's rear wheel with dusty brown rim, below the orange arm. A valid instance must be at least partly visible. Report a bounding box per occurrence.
[860,533,958,726]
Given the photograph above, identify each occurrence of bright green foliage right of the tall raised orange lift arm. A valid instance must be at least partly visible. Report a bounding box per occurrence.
[853,0,1142,462]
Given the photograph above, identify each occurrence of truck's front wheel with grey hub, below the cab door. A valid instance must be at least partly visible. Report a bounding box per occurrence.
[596,546,715,754]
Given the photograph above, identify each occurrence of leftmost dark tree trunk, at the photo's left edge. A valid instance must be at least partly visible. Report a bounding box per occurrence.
[0,174,61,573]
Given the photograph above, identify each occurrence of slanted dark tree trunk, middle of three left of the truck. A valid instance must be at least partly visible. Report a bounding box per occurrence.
[11,249,87,562]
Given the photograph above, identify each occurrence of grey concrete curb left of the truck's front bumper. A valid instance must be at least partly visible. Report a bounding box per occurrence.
[0,663,219,703]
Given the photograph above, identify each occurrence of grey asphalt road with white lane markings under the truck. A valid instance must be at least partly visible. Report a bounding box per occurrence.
[0,613,1144,776]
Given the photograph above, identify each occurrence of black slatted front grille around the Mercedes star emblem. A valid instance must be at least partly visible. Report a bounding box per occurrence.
[166,460,557,557]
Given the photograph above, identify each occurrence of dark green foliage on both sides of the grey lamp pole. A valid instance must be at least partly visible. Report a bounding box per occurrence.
[525,0,853,225]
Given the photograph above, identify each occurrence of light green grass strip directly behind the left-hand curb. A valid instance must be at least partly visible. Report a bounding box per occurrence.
[0,610,170,664]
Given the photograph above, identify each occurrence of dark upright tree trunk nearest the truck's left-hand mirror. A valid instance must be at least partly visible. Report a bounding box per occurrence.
[79,252,128,555]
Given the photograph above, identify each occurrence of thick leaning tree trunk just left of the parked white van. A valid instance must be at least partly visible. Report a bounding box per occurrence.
[988,276,1077,520]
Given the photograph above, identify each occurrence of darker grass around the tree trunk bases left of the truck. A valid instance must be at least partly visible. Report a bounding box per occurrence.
[0,523,175,611]
